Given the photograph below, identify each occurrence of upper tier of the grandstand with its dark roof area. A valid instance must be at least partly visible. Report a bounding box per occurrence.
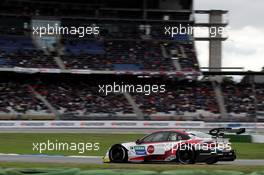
[0,1,199,73]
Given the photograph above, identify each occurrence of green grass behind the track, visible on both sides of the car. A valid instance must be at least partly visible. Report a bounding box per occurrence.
[0,133,264,159]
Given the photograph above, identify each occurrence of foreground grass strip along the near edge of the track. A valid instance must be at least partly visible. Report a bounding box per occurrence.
[0,162,264,173]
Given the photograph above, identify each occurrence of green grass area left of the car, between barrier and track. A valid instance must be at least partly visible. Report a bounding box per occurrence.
[0,133,144,156]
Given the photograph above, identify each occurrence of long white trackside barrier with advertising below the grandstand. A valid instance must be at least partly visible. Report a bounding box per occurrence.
[0,120,264,129]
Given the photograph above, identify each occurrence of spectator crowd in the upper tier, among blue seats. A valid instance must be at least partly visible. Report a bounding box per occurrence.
[0,36,199,72]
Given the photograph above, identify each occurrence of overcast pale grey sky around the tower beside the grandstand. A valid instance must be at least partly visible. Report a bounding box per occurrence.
[194,0,264,71]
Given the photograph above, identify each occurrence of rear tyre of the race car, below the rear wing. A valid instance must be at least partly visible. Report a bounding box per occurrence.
[176,145,195,164]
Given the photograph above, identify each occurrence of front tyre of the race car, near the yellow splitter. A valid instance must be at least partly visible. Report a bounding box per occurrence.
[109,145,128,163]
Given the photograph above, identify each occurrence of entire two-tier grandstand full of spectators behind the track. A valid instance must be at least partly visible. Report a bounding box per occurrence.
[0,0,264,122]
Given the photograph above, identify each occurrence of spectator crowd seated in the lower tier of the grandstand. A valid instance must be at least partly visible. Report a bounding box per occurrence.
[0,81,264,121]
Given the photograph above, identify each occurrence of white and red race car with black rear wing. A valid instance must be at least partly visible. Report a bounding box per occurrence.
[103,128,245,164]
